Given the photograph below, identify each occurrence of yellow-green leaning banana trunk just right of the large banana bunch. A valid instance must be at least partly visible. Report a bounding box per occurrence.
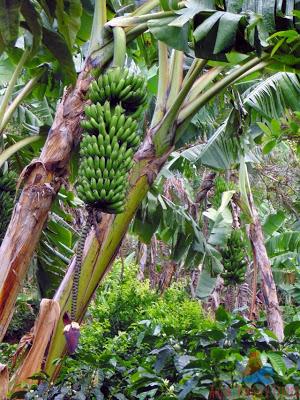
[10,135,173,391]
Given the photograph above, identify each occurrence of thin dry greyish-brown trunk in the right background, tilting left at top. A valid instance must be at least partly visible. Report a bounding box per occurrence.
[249,193,284,341]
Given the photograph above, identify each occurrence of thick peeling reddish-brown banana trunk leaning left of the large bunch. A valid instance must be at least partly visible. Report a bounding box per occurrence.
[0,51,112,341]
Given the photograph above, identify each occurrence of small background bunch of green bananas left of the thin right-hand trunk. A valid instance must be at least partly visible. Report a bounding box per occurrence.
[221,229,246,286]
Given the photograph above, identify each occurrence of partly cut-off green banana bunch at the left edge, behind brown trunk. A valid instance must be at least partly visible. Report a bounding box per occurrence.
[0,171,18,244]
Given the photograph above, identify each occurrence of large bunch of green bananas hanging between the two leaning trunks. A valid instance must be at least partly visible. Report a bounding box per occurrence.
[77,68,147,214]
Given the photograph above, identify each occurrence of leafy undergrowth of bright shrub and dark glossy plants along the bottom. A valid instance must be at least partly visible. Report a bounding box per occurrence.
[21,266,300,400]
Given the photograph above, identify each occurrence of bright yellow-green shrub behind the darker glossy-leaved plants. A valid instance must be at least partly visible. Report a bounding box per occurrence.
[74,263,211,363]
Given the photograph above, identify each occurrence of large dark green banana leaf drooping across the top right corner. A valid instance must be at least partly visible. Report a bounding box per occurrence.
[144,0,299,61]
